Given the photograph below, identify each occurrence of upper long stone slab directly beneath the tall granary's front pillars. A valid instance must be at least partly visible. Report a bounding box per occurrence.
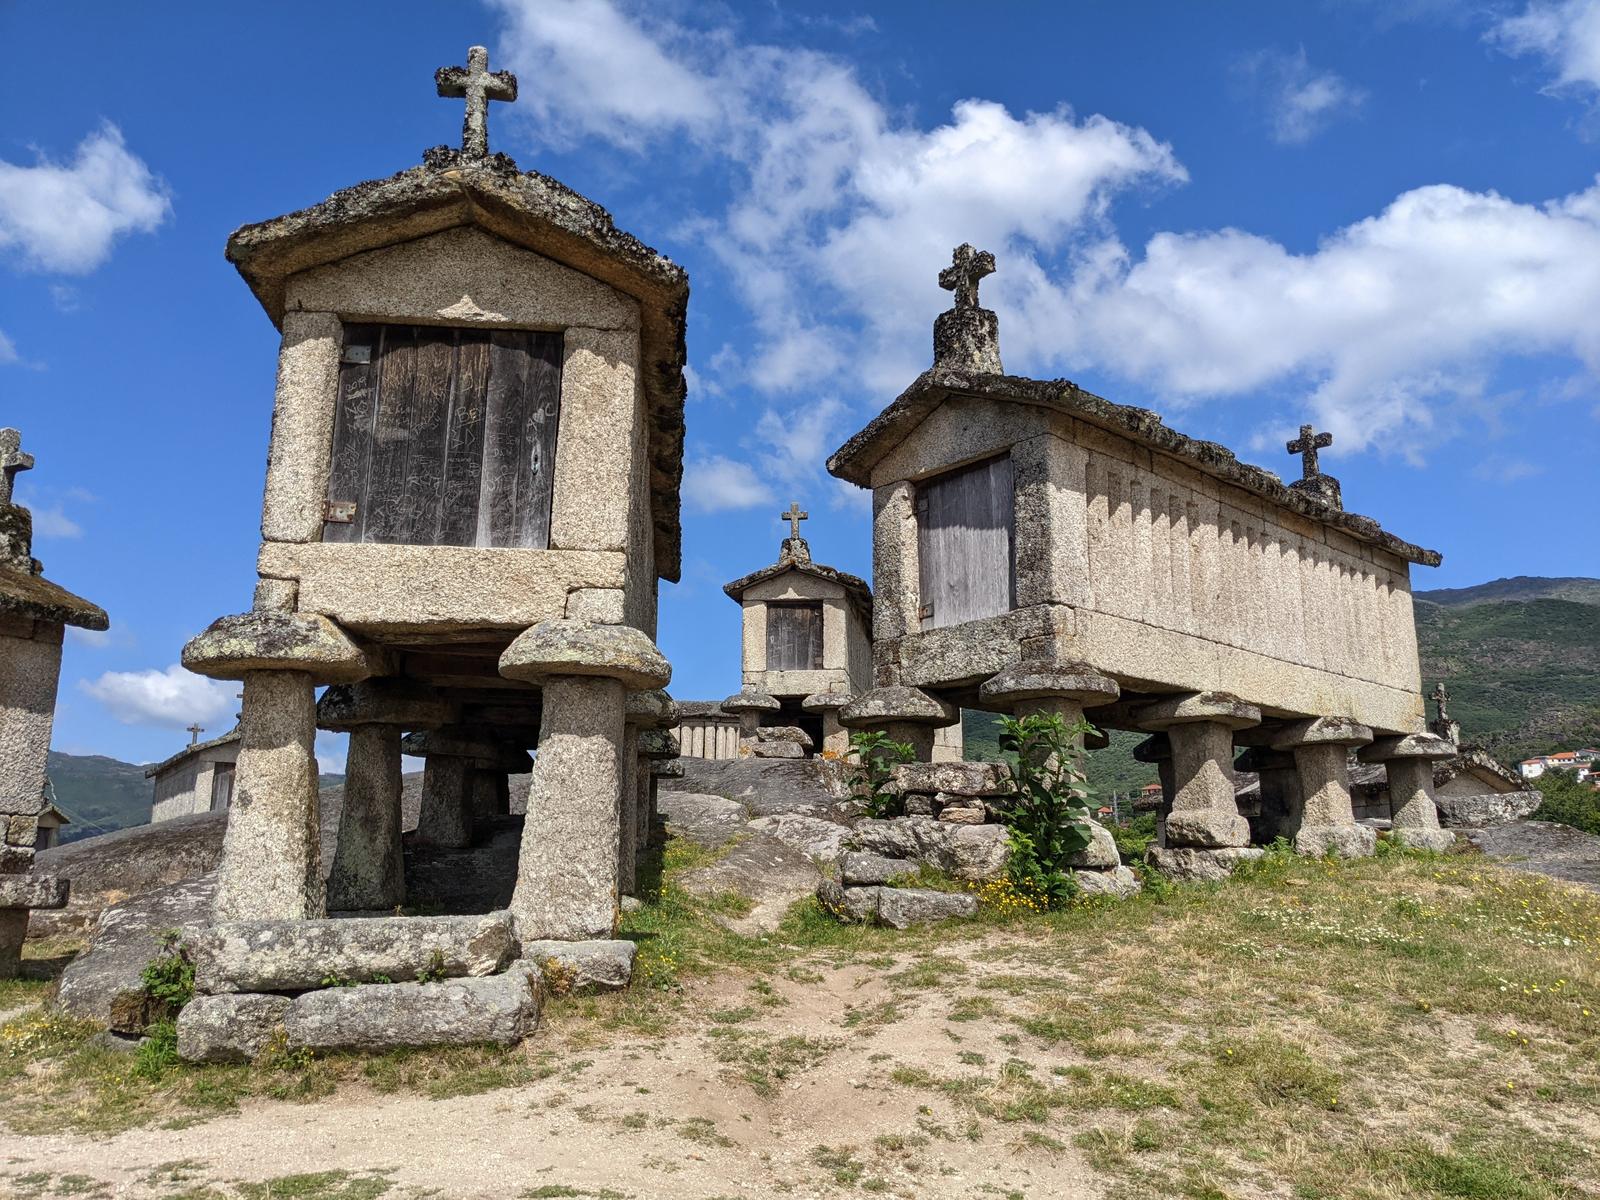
[189,912,515,994]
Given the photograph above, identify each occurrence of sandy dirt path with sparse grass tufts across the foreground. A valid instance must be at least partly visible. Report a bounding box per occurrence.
[0,947,1101,1200]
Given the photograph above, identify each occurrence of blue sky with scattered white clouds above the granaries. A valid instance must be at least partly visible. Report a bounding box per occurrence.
[0,0,1600,762]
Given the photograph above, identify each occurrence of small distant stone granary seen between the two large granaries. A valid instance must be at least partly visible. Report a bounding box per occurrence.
[723,504,872,757]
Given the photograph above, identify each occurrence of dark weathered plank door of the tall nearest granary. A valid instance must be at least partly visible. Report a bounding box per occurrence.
[323,325,562,549]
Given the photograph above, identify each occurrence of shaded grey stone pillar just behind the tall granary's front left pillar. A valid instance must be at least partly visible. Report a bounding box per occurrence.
[328,725,405,912]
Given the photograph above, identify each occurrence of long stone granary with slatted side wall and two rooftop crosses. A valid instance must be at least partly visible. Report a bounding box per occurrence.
[827,246,1451,874]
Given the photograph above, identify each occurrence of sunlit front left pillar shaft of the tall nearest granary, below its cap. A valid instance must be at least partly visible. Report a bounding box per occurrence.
[213,670,326,920]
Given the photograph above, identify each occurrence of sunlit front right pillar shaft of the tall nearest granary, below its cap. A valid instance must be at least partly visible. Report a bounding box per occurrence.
[510,675,624,941]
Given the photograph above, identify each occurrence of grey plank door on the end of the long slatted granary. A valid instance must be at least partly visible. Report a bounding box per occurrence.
[917,458,1016,629]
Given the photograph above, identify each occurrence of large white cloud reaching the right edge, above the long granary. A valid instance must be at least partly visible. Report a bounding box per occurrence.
[1056,182,1600,450]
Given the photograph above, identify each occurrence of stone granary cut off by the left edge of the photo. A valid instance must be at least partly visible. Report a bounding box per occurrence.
[0,429,110,979]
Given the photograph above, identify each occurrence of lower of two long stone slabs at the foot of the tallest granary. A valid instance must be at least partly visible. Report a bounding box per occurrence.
[178,965,542,1062]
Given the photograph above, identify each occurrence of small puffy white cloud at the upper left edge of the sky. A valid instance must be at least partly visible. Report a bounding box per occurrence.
[0,125,171,275]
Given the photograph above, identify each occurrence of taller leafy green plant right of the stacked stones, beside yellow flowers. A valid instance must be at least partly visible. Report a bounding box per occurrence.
[1000,712,1093,907]
